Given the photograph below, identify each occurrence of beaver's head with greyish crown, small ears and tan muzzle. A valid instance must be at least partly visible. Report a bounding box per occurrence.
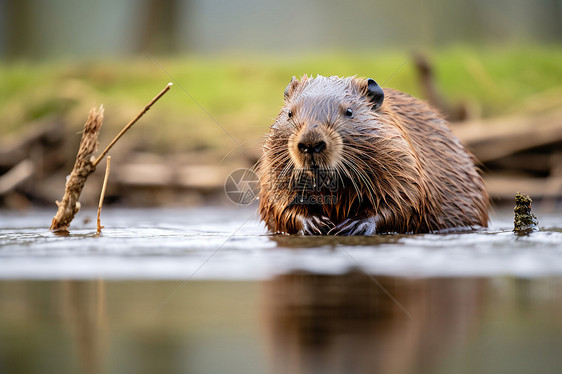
[273,76,384,171]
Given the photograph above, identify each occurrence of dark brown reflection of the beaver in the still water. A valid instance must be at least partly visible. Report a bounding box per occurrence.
[264,271,481,374]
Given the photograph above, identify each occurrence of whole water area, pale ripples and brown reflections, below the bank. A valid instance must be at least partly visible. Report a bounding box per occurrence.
[0,208,562,373]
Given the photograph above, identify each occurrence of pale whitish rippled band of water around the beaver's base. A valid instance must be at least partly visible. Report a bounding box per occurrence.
[0,208,562,280]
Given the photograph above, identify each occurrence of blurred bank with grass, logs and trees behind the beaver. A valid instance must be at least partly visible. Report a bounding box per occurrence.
[0,0,562,209]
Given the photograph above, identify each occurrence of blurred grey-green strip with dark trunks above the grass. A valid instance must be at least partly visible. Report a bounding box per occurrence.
[0,0,562,57]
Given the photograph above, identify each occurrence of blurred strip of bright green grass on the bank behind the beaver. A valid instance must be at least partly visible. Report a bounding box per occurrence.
[0,46,562,152]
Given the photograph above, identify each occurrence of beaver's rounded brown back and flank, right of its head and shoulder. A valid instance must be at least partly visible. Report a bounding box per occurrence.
[381,89,489,231]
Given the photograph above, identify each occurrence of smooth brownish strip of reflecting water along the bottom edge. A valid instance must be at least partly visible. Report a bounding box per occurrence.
[0,271,562,374]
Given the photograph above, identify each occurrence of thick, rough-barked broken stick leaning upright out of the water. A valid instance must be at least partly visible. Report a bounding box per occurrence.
[49,105,103,232]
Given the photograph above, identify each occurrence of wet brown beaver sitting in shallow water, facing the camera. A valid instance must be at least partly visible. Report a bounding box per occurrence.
[257,75,489,235]
